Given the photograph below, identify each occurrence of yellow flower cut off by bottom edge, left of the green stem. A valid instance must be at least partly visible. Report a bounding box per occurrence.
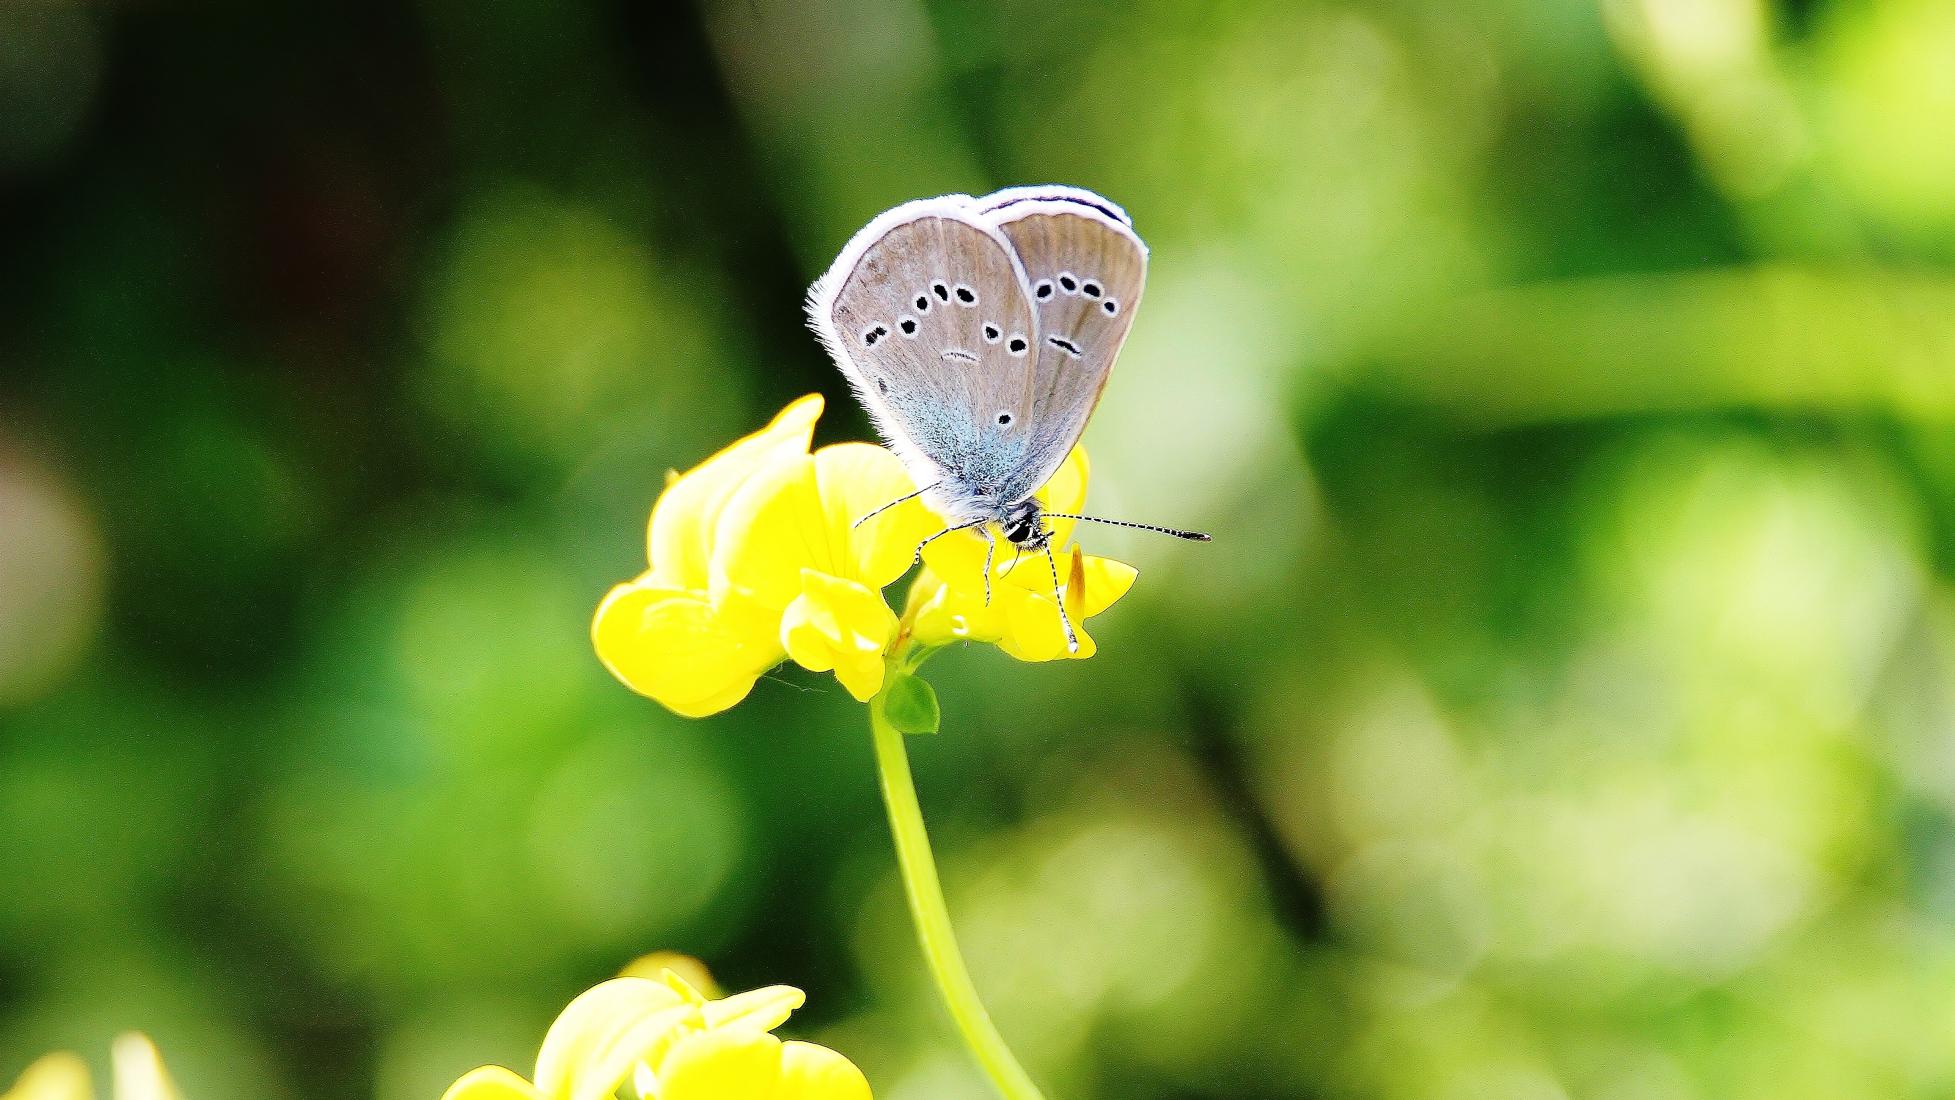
[442,971,870,1100]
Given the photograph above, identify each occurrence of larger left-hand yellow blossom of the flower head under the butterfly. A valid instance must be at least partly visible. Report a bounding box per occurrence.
[590,395,942,717]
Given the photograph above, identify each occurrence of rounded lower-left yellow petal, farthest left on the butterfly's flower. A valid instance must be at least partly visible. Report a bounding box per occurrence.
[590,582,782,717]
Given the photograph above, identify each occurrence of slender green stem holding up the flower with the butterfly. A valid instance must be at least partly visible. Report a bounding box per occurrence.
[868,660,1044,1100]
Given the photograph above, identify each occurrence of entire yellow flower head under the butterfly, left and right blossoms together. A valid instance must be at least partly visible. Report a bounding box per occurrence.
[590,395,1136,717]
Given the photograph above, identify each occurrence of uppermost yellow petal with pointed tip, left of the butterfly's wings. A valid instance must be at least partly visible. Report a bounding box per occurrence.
[647,393,821,590]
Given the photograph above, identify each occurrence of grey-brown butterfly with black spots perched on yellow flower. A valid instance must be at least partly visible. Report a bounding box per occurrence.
[807,186,1208,653]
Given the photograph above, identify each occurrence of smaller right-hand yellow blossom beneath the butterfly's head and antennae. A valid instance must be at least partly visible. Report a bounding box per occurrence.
[909,447,1138,660]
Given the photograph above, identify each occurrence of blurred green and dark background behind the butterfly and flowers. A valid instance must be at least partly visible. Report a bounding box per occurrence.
[0,0,1955,1100]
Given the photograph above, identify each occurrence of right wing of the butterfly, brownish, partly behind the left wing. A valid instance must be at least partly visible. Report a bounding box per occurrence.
[974,188,1148,498]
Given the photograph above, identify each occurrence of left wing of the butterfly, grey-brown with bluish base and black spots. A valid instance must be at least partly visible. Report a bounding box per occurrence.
[807,195,1038,518]
